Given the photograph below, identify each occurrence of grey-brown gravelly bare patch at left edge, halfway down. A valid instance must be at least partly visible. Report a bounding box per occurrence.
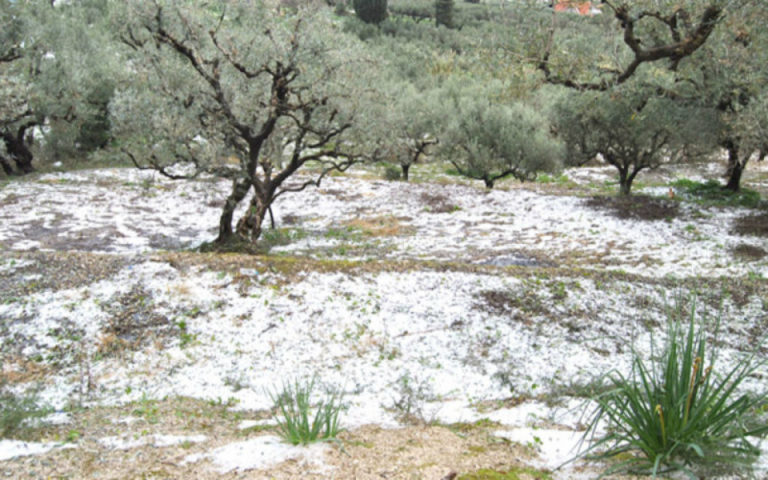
[0,252,129,302]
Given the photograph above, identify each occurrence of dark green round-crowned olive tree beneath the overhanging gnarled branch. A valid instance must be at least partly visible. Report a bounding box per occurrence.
[553,86,720,195]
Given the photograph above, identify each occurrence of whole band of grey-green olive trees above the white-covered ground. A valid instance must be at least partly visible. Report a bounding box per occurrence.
[0,0,768,244]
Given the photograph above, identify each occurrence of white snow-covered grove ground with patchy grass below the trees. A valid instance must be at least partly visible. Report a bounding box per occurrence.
[0,165,768,478]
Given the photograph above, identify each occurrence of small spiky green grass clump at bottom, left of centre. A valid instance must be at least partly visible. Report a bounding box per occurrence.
[272,378,343,445]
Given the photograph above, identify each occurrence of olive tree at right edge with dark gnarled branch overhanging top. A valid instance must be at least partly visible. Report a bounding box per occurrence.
[538,0,768,191]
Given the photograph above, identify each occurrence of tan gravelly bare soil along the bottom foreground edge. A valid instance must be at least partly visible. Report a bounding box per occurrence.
[0,398,535,480]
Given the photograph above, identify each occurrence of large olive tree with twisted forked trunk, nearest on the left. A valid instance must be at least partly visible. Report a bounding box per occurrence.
[111,0,375,244]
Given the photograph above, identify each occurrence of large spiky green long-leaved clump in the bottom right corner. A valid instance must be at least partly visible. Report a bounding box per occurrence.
[585,300,768,478]
